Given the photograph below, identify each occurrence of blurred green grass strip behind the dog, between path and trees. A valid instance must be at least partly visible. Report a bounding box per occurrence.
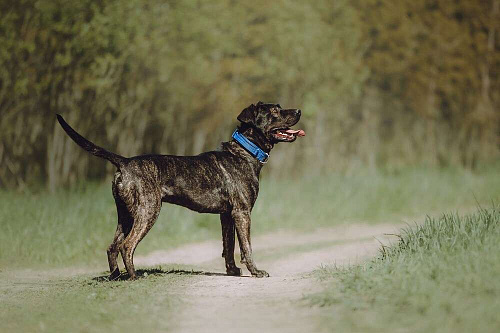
[0,164,500,269]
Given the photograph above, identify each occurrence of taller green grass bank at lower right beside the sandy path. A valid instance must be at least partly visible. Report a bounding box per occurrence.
[309,206,500,332]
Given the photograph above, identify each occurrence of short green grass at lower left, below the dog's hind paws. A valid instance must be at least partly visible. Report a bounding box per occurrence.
[0,269,193,332]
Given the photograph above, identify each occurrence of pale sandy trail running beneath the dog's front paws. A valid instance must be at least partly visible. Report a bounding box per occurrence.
[136,224,400,332]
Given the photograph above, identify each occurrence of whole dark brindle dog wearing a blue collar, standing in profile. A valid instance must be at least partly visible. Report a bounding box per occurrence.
[57,102,305,280]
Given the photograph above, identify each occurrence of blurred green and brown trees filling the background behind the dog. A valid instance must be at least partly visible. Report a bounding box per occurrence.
[0,0,500,189]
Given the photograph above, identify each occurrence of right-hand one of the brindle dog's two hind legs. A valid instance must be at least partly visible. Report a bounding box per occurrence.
[120,191,161,280]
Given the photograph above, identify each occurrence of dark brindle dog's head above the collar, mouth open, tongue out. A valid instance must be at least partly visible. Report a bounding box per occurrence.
[238,102,306,146]
